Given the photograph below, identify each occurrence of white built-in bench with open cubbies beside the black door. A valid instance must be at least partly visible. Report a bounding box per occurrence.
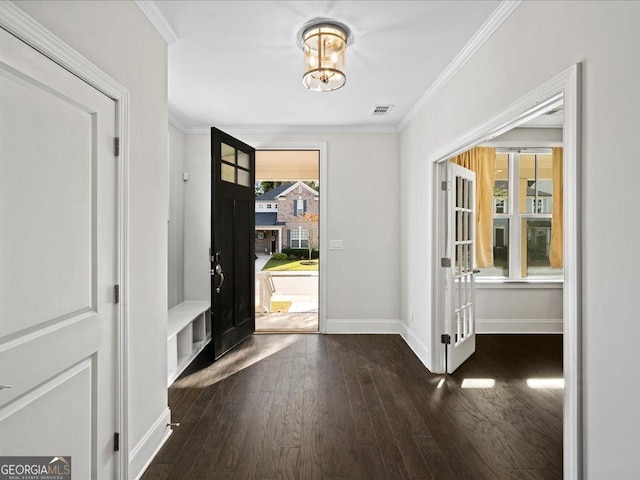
[167,301,211,385]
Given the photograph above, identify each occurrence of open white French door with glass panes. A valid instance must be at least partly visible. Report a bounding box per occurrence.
[445,162,476,373]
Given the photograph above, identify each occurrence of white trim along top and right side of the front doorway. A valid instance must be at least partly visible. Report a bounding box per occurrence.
[249,141,329,333]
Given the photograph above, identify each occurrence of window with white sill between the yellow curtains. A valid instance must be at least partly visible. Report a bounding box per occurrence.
[479,149,563,279]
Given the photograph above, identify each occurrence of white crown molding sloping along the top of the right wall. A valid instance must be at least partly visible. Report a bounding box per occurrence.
[398,0,522,131]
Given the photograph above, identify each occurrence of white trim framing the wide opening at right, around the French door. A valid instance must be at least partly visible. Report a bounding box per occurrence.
[428,63,584,478]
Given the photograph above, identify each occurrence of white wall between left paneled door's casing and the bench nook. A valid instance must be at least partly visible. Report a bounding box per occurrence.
[16,1,168,477]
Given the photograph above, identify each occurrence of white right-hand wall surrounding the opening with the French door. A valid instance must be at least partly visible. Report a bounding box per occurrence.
[401,1,640,479]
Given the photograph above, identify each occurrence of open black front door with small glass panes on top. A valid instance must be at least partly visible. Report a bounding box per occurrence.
[210,128,255,358]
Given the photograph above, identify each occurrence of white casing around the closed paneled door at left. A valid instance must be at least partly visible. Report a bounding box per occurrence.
[0,2,129,478]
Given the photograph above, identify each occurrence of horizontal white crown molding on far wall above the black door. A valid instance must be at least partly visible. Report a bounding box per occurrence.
[175,124,400,135]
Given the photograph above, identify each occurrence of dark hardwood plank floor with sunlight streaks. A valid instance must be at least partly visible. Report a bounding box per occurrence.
[143,334,563,480]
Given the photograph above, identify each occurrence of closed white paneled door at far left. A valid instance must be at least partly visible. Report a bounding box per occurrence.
[0,29,118,479]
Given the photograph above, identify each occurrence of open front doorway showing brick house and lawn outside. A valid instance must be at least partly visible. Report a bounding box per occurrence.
[255,150,321,333]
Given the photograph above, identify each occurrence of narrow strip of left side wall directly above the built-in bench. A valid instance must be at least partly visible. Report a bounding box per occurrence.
[168,125,185,308]
